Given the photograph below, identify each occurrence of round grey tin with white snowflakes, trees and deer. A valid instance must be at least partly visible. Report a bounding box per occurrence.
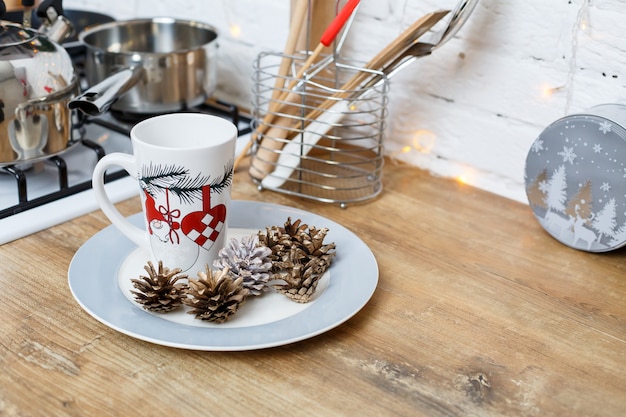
[524,104,626,252]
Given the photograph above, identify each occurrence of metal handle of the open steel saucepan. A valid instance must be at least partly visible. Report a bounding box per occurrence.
[68,65,143,116]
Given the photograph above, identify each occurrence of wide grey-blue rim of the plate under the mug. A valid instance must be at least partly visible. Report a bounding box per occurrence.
[68,200,379,351]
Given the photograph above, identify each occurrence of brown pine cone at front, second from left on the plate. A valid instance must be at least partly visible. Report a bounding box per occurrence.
[183,265,248,323]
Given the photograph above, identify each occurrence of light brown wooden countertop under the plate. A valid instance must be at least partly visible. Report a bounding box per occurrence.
[0,163,626,417]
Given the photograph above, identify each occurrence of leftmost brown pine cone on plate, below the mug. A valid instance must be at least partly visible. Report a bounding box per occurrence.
[131,261,187,313]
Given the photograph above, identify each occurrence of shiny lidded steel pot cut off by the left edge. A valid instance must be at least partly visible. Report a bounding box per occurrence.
[0,0,79,166]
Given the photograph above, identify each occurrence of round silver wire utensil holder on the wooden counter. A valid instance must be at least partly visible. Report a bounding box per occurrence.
[250,52,389,206]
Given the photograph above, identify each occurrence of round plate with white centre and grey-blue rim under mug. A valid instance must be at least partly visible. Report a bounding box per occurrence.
[68,201,378,351]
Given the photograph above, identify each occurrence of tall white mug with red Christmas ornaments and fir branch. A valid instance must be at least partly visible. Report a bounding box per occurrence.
[92,113,237,275]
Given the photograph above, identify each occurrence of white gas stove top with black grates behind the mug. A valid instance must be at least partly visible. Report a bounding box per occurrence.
[0,100,250,245]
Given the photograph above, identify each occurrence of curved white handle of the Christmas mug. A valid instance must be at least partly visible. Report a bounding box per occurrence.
[91,152,150,248]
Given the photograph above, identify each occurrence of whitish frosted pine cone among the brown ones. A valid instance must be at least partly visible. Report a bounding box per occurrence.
[213,235,272,296]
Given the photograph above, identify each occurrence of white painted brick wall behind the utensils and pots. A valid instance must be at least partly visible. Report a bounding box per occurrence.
[65,0,626,202]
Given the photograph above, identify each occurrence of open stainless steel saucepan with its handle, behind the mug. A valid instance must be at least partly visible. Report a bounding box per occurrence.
[69,18,217,115]
